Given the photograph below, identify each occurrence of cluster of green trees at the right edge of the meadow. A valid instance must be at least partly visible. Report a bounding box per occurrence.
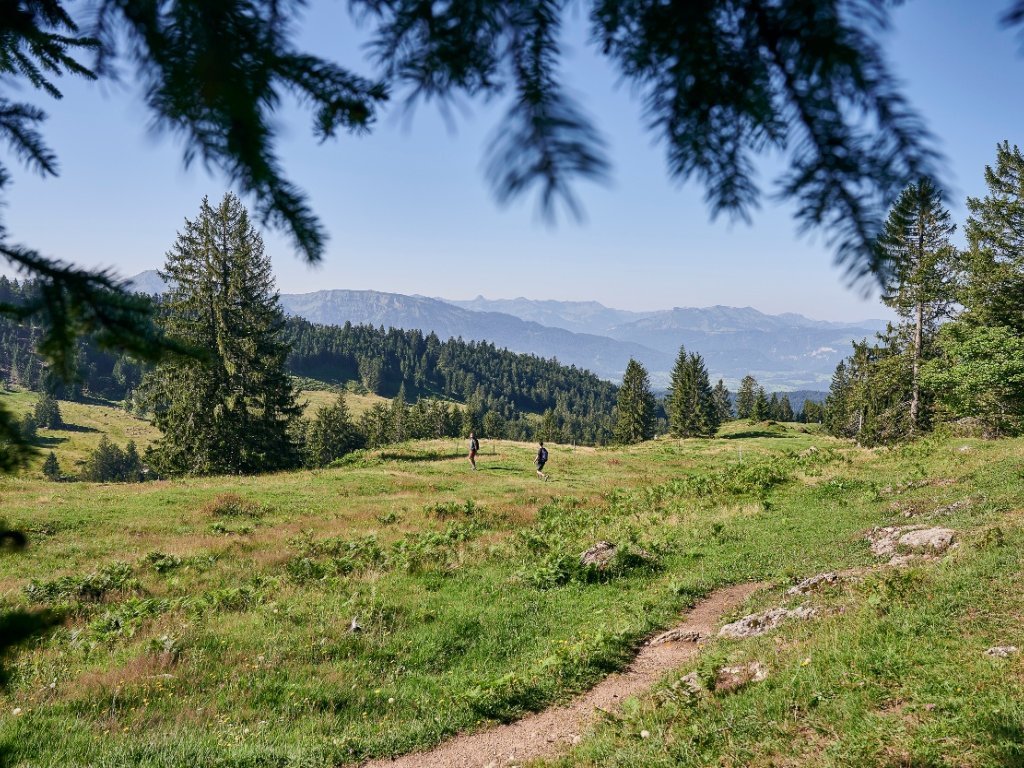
[823,141,1024,444]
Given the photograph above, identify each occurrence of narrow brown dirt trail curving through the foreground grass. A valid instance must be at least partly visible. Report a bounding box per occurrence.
[362,584,764,768]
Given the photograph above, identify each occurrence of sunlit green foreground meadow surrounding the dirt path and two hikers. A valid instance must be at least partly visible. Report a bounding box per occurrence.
[0,421,1024,766]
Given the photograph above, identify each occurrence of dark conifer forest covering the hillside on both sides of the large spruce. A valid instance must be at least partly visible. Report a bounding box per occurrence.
[0,284,616,444]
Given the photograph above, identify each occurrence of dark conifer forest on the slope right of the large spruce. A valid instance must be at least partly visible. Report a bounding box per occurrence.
[284,317,617,444]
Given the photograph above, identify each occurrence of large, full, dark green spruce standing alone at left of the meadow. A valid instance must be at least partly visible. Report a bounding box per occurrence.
[144,194,299,474]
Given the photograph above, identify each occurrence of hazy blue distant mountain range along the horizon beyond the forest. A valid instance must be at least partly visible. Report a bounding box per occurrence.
[125,271,885,390]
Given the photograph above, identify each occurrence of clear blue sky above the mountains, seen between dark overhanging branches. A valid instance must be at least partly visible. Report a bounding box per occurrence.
[3,0,1024,319]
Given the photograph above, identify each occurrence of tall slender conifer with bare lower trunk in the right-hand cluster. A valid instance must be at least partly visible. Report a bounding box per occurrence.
[879,179,961,431]
